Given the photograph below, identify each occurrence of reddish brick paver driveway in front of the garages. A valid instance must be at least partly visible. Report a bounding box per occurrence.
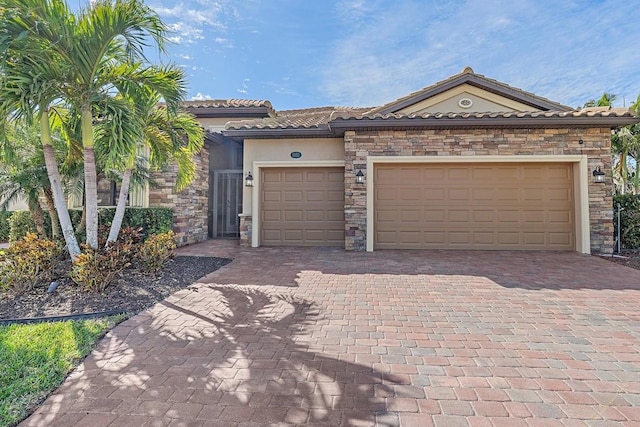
[24,242,640,427]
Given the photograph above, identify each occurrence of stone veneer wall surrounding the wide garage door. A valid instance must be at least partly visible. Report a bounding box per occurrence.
[344,128,613,253]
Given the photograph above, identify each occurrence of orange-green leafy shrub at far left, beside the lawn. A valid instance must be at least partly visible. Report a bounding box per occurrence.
[0,233,62,292]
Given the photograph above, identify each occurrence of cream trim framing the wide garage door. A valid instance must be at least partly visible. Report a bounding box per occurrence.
[366,155,591,254]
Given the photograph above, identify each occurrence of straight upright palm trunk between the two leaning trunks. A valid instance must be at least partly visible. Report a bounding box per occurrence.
[82,106,98,249]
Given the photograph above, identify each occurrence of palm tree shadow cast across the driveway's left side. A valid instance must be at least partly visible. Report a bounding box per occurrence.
[25,285,402,425]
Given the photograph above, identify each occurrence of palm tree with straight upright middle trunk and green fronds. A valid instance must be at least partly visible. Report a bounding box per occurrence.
[2,0,167,248]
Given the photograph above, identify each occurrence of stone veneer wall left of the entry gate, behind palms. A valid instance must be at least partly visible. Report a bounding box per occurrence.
[149,146,209,246]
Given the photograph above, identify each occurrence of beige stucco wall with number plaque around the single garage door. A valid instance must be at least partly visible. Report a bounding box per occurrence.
[242,138,344,215]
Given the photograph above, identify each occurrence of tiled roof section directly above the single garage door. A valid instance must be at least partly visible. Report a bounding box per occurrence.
[226,107,370,130]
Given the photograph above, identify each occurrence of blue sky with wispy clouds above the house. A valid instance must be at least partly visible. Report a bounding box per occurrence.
[147,0,640,110]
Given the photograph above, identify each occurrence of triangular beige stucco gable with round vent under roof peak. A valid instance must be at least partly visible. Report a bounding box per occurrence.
[400,84,538,114]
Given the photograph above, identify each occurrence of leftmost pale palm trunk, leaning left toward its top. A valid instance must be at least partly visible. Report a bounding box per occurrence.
[40,110,80,261]
